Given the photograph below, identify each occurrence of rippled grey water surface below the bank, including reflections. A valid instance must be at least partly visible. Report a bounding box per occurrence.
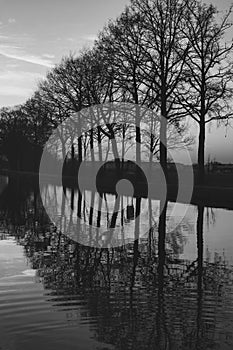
[0,179,233,350]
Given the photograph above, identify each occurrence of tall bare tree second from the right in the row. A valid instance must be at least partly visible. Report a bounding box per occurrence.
[131,0,191,174]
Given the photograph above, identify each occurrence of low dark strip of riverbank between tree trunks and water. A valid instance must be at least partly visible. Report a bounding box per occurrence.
[1,171,233,209]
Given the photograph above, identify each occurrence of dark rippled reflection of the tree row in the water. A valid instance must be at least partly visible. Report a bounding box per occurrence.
[0,176,233,350]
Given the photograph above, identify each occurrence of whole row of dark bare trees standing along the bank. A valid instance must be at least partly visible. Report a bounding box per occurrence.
[0,0,233,181]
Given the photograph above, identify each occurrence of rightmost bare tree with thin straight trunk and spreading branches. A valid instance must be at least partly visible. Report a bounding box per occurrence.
[176,2,233,182]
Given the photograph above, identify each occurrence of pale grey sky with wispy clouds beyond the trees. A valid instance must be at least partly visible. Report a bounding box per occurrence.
[0,0,233,163]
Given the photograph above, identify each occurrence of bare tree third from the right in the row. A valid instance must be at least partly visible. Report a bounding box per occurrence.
[98,7,152,163]
